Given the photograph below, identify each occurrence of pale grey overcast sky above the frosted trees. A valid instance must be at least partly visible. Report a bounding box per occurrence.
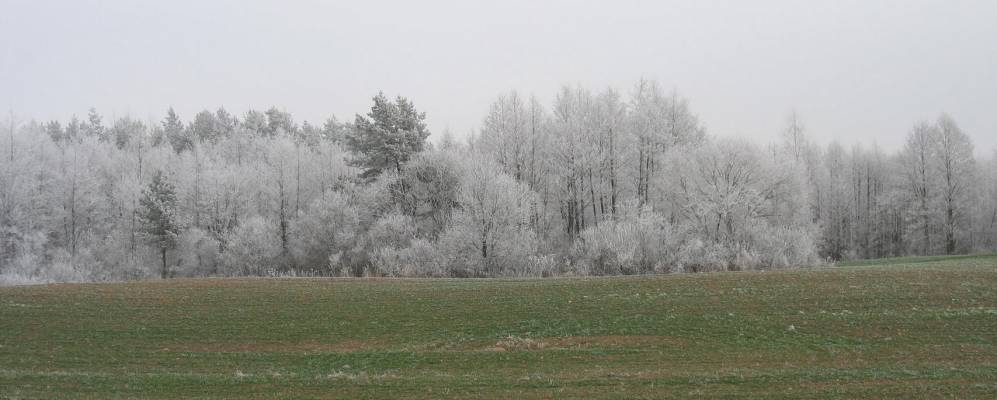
[0,0,997,154]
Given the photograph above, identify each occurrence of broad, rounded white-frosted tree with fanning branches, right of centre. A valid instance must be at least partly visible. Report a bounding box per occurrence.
[665,140,815,269]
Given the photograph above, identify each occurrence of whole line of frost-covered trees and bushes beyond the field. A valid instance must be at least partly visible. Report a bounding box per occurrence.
[0,80,997,283]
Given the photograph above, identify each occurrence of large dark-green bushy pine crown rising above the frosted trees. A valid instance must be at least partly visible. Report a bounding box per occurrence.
[346,92,429,179]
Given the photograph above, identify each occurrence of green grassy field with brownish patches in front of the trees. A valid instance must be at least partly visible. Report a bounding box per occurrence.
[0,256,997,399]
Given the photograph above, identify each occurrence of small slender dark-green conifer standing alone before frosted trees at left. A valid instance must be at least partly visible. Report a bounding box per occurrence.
[139,171,181,279]
